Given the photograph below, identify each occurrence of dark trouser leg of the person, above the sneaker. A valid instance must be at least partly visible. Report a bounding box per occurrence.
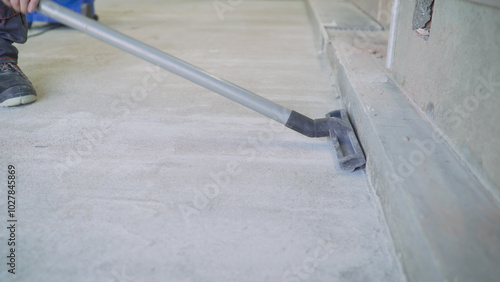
[0,1,28,64]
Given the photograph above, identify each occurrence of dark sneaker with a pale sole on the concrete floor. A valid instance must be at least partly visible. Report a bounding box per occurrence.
[0,63,36,107]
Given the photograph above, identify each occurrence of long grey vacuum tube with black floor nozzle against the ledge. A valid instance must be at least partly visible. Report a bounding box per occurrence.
[37,0,365,171]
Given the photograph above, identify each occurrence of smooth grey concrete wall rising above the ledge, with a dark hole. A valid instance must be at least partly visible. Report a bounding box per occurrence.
[393,0,500,196]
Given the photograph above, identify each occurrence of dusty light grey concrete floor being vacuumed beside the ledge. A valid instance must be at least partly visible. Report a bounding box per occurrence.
[0,0,405,282]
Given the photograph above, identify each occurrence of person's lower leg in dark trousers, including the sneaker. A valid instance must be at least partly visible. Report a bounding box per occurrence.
[0,1,36,106]
